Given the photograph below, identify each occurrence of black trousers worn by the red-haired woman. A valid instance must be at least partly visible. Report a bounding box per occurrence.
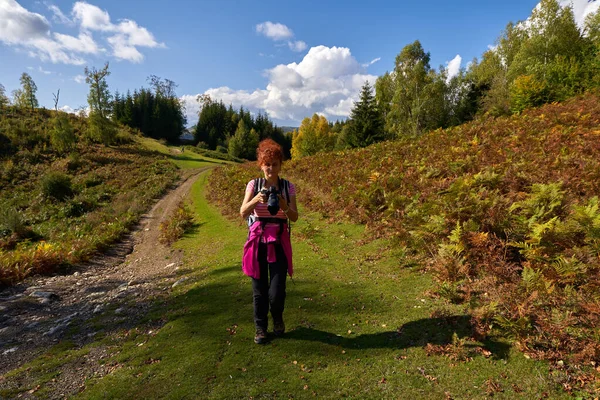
[252,243,287,331]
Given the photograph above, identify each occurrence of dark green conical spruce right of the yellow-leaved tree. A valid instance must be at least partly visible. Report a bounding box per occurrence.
[346,81,385,147]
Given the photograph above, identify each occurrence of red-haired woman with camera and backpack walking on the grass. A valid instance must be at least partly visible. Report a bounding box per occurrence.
[240,139,298,344]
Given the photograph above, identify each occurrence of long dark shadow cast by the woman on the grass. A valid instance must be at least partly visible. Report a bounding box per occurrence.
[282,315,510,359]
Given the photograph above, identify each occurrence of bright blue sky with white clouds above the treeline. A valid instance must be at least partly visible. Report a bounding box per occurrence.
[0,0,600,126]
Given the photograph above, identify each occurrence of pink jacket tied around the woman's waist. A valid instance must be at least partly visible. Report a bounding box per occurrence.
[242,221,294,279]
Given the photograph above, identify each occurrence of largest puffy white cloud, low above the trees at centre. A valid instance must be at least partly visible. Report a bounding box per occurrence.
[182,46,377,123]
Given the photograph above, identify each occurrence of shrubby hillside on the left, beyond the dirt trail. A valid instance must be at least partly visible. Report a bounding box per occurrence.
[0,109,178,286]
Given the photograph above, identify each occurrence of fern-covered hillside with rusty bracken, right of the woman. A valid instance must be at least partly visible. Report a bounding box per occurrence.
[210,93,600,389]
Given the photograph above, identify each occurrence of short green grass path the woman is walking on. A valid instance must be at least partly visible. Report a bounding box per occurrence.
[0,173,568,399]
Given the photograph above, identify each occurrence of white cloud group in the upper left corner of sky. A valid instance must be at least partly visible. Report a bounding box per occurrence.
[0,0,165,65]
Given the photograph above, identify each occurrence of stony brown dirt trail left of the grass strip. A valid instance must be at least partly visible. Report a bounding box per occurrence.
[0,167,208,398]
